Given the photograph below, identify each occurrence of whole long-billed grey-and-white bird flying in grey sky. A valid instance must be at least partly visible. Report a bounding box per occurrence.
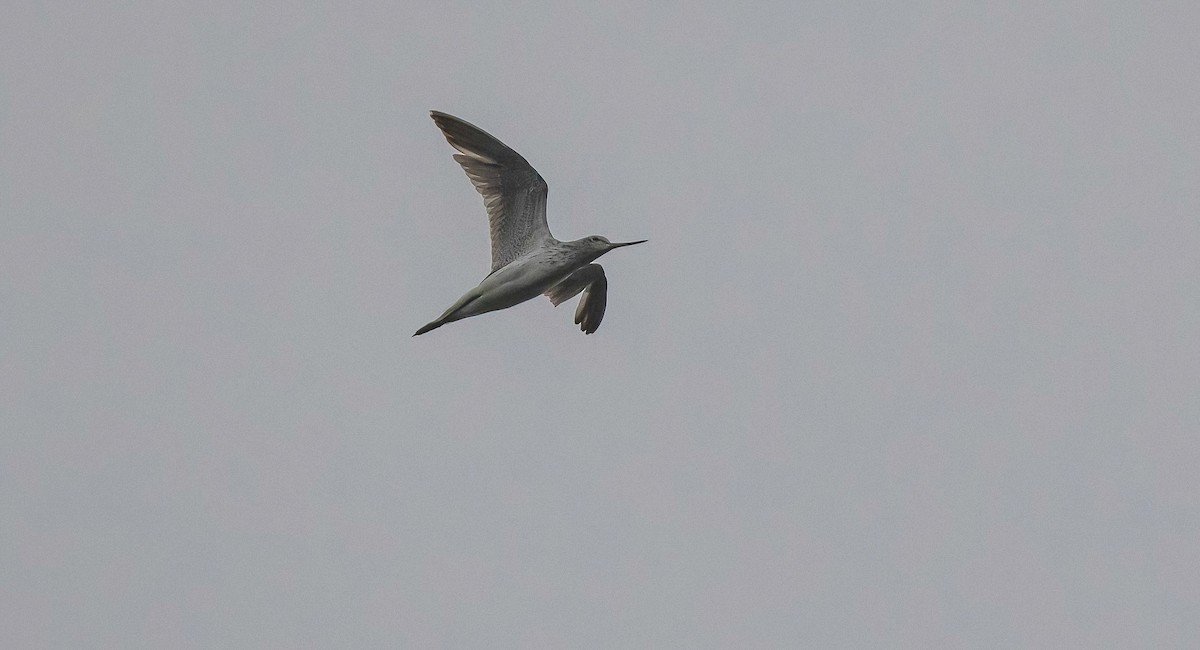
[413,110,648,336]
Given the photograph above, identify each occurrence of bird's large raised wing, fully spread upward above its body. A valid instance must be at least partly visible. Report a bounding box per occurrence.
[430,110,551,271]
